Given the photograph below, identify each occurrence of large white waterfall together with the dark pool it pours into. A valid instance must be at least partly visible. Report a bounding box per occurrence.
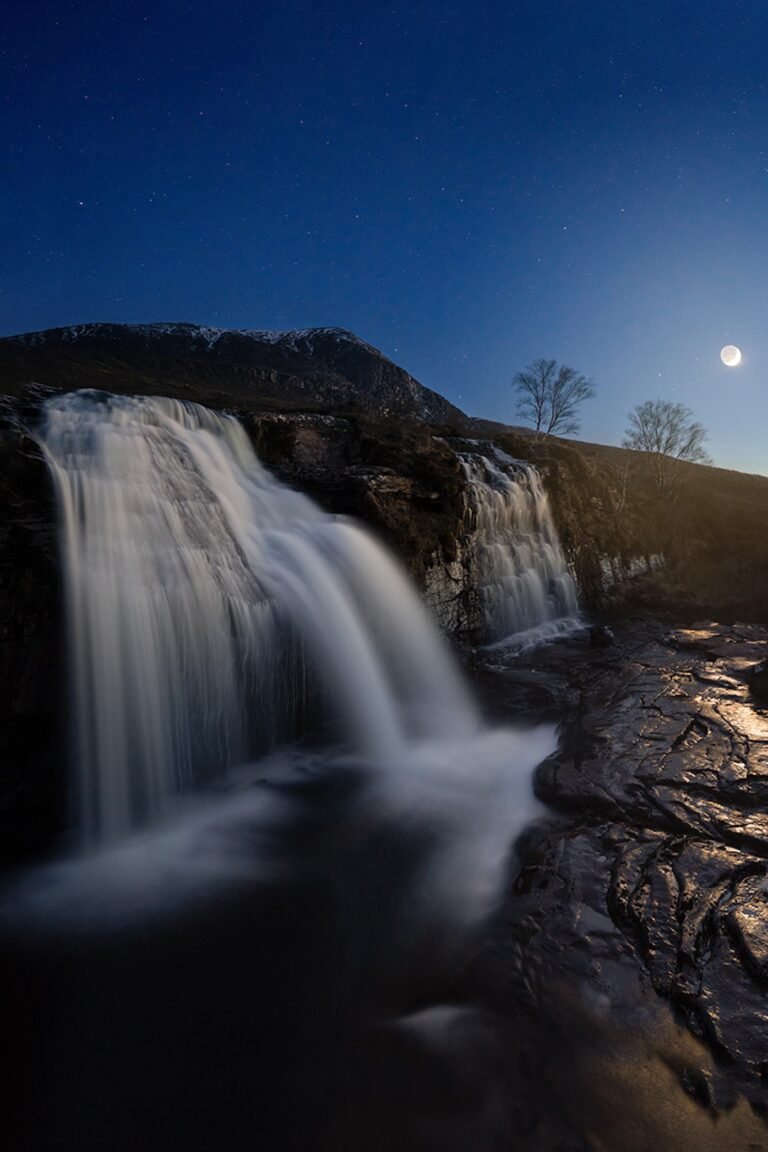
[0,392,565,1152]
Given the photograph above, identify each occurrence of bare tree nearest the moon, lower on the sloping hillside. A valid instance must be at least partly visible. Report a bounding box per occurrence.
[622,400,712,488]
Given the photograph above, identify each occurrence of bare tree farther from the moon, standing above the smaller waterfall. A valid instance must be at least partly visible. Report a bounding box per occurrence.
[512,359,595,435]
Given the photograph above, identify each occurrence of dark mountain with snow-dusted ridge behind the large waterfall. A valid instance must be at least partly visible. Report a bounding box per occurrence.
[0,321,470,430]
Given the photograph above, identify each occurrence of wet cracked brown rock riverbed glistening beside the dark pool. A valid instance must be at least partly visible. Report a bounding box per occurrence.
[462,621,768,1152]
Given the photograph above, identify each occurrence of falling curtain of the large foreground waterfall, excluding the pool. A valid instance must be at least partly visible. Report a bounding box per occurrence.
[40,392,477,843]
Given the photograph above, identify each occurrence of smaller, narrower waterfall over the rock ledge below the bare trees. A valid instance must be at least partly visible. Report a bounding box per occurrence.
[462,449,580,650]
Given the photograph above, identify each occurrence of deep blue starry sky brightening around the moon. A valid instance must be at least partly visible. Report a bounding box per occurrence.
[0,0,768,473]
